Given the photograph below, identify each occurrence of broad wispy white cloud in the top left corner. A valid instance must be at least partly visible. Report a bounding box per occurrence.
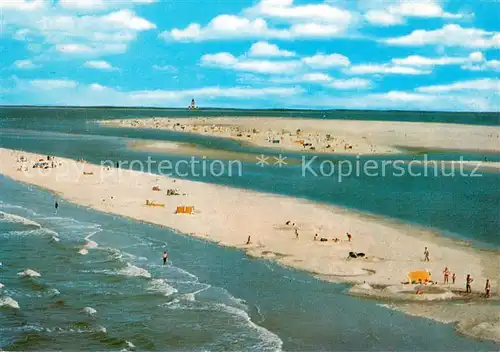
[2,4,156,59]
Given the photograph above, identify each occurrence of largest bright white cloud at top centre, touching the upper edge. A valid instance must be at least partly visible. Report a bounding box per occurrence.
[160,0,352,42]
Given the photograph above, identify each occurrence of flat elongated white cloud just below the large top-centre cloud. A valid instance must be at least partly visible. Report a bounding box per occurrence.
[201,52,301,73]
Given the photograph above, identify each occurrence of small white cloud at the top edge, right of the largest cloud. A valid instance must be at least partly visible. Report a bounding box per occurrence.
[365,0,464,26]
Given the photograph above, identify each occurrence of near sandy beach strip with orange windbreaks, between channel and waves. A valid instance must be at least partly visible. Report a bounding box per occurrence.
[0,149,500,341]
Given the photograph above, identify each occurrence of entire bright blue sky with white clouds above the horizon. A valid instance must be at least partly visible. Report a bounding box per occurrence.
[0,0,500,111]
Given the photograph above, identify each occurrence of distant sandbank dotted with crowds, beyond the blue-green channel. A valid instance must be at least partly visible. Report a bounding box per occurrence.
[100,117,500,155]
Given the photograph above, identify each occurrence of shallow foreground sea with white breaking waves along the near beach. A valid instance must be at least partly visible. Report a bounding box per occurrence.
[0,177,495,351]
